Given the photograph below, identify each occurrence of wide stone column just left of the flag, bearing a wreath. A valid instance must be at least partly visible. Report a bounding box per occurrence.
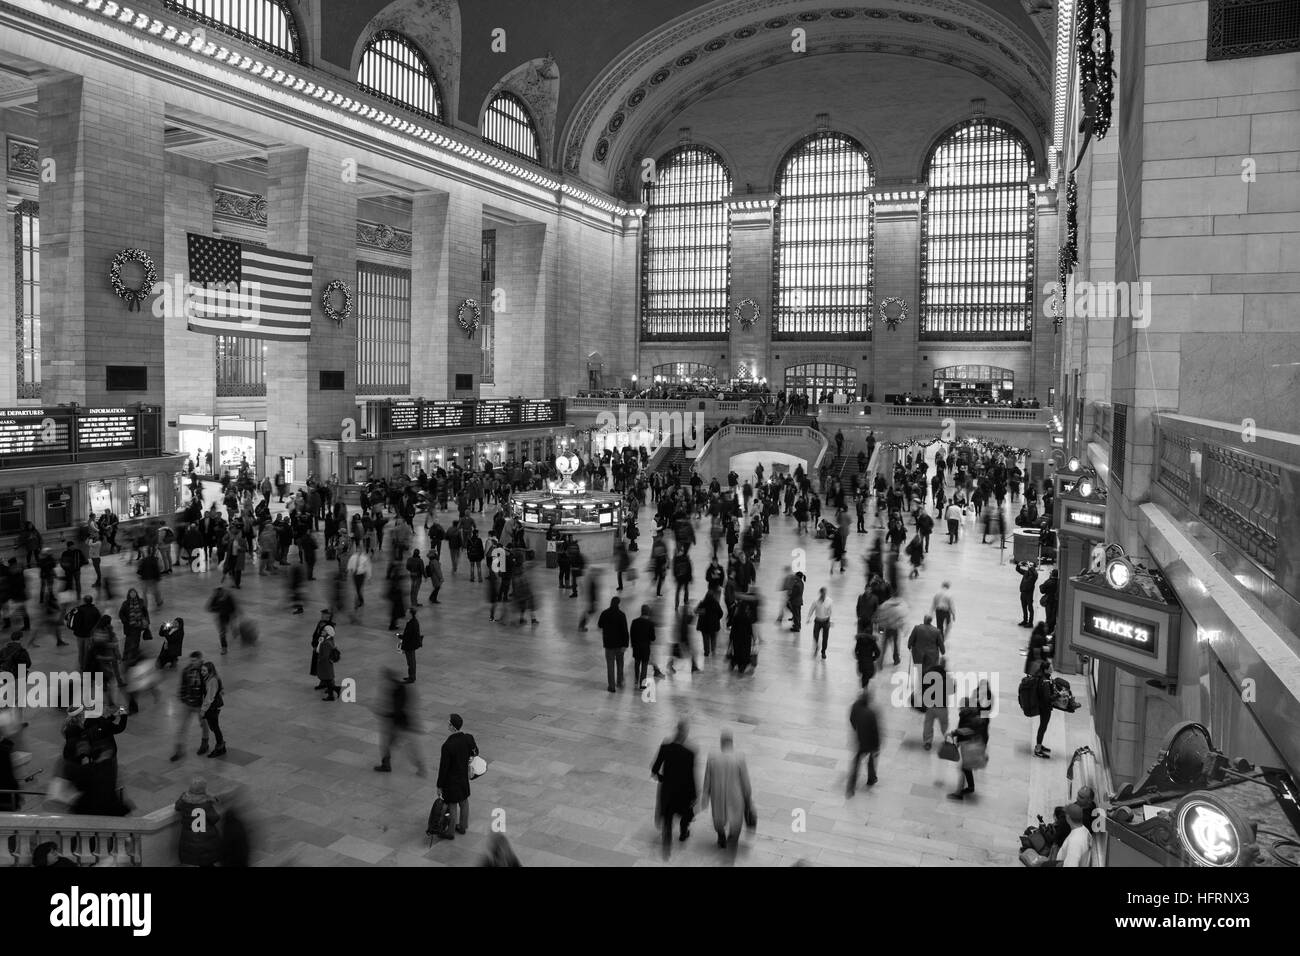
[37,77,169,406]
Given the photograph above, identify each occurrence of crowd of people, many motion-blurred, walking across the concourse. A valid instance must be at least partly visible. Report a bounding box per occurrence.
[0,421,1076,860]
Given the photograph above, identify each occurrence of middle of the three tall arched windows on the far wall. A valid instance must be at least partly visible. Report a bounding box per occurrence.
[772,131,874,338]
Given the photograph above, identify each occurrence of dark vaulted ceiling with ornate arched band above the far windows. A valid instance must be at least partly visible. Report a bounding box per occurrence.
[317,0,1056,180]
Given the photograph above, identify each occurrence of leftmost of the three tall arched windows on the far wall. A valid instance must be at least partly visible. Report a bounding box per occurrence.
[641,146,732,339]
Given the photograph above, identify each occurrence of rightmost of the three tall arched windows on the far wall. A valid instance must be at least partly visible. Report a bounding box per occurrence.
[920,120,1035,341]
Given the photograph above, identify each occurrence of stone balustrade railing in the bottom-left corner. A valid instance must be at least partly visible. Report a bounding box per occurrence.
[0,806,179,868]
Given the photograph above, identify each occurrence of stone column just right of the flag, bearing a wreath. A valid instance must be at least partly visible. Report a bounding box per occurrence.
[264,147,356,483]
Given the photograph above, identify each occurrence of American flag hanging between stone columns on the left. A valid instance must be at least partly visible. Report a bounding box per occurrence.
[186,233,312,342]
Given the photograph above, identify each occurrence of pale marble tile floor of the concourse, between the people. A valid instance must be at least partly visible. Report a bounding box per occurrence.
[10,489,1091,866]
